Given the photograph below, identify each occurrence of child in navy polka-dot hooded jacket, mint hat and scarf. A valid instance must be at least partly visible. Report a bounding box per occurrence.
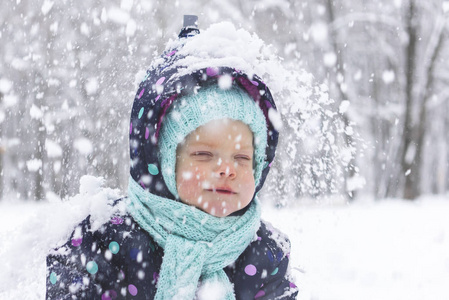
[47,17,297,299]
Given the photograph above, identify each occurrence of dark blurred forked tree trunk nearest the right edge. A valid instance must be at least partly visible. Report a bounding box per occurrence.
[401,0,446,199]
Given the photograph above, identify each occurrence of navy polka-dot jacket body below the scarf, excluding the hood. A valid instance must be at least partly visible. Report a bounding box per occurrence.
[47,207,296,300]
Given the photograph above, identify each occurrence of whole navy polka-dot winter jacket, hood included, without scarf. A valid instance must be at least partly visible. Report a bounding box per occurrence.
[47,21,297,300]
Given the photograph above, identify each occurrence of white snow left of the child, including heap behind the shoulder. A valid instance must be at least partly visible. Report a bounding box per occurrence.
[0,176,125,299]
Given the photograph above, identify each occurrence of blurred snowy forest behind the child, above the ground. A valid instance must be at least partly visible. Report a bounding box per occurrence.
[0,0,449,203]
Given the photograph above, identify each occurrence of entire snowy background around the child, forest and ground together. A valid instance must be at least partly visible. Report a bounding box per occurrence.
[0,0,449,300]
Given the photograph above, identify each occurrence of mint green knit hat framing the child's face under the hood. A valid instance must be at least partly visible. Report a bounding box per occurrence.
[159,85,267,198]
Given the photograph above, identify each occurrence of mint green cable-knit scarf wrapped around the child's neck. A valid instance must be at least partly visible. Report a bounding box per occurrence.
[128,177,260,300]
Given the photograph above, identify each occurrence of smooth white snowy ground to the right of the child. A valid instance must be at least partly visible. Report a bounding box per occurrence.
[265,198,449,300]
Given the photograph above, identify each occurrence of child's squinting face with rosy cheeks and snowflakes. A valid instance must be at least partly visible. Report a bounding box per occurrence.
[176,119,256,217]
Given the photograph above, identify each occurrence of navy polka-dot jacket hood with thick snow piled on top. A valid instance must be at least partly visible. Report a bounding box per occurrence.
[129,23,279,199]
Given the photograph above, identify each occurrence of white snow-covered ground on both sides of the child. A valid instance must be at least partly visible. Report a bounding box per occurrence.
[0,184,449,300]
